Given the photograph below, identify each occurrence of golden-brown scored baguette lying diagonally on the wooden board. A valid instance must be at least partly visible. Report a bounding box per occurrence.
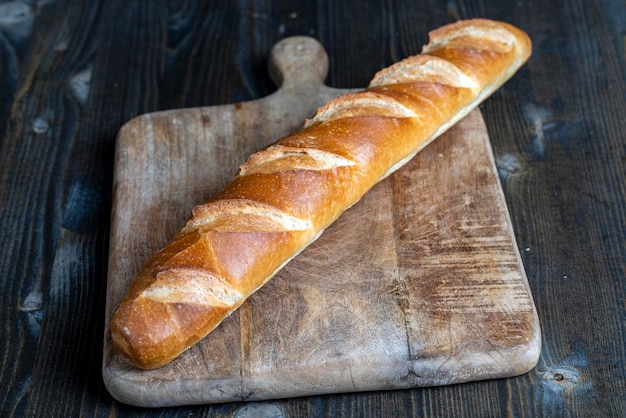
[110,19,531,369]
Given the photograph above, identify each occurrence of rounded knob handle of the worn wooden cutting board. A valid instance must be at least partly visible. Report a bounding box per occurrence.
[268,36,328,89]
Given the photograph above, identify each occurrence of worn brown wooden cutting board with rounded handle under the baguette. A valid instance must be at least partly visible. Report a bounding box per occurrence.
[103,37,541,406]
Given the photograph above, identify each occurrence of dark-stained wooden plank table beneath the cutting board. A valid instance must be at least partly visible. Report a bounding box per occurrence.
[0,0,626,417]
